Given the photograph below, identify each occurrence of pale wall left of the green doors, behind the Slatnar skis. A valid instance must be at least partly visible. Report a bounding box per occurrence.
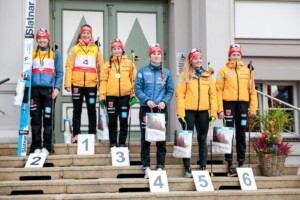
[0,0,49,143]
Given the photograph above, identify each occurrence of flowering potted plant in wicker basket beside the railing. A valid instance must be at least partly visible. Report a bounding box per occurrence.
[251,108,293,176]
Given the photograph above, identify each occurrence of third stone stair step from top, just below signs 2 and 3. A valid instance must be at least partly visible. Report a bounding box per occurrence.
[0,164,298,181]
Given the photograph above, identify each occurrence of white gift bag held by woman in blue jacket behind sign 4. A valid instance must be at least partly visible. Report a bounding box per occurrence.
[145,113,166,142]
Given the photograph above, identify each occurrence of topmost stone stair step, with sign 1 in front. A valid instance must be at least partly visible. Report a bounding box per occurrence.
[0,141,254,156]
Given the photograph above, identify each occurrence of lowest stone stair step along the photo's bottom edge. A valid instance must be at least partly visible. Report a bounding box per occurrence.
[0,188,300,200]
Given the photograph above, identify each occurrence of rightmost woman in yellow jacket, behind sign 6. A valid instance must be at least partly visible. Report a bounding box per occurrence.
[216,44,257,176]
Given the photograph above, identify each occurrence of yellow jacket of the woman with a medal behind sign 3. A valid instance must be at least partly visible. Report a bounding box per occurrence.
[99,55,136,100]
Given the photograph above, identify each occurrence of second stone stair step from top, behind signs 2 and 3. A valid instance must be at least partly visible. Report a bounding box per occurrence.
[0,153,259,168]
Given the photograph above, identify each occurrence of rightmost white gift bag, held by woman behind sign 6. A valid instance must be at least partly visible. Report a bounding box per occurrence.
[212,126,233,154]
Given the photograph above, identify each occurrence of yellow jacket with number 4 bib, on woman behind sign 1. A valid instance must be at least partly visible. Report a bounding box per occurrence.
[65,41,103,88]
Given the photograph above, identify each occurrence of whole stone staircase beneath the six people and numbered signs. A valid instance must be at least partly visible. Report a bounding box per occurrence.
[0,142,300,200]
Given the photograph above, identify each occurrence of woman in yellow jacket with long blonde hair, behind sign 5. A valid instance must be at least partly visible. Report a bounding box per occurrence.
[176,49,217,178]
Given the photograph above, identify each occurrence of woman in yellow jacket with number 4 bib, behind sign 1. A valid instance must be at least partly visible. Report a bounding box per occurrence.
[65,24,103,143]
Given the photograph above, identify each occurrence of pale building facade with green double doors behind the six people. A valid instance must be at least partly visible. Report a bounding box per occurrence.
[0,0,300,146]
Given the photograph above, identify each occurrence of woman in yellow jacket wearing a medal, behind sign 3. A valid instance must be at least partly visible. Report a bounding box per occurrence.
[99,39,136,147]
